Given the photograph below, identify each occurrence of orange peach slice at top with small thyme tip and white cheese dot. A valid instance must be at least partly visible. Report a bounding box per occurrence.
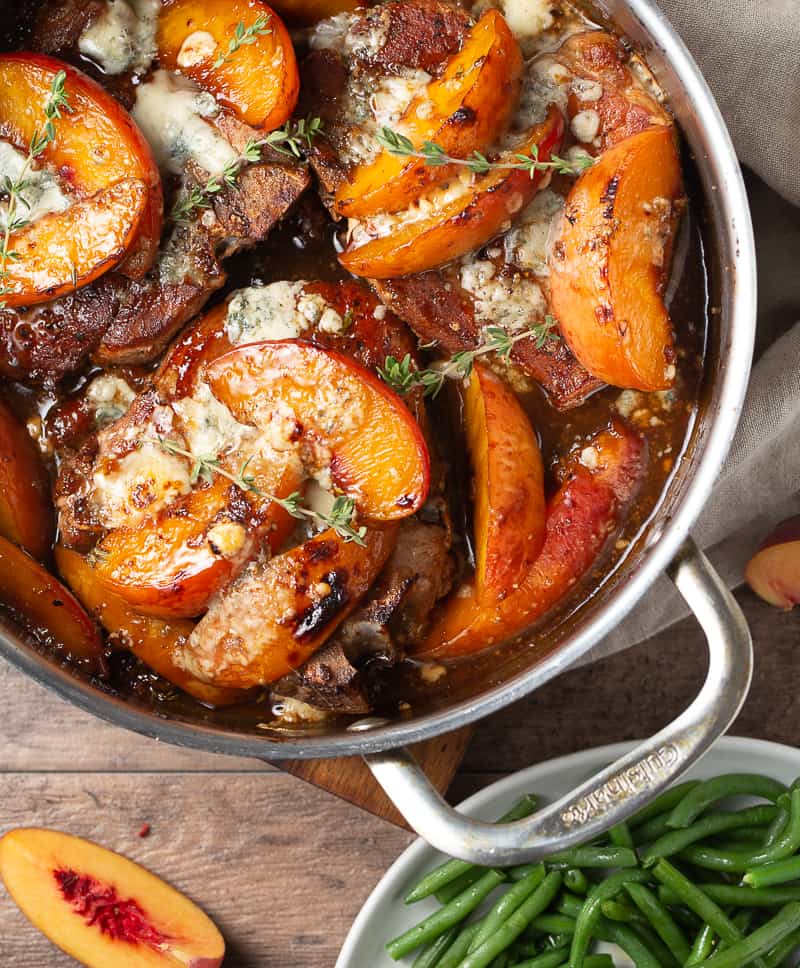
[157,0,300,131]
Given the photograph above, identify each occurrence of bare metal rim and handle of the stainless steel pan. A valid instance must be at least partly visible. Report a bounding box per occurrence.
[0,0,756,864]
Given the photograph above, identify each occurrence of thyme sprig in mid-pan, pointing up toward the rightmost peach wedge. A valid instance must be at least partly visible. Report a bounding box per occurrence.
[378,316,558,397]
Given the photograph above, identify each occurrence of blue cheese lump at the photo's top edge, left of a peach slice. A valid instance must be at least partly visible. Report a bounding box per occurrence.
[78,0,161,74]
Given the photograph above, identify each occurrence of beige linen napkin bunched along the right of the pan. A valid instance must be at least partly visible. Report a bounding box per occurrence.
[591,0,800,659]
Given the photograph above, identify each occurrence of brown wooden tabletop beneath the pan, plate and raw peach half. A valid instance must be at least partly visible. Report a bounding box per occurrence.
[0,591,800,968]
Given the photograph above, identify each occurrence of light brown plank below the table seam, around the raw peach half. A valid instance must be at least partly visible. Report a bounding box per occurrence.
[0,773,412,968]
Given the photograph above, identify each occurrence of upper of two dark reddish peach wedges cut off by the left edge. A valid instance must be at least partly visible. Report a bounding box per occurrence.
[0,400,54,561]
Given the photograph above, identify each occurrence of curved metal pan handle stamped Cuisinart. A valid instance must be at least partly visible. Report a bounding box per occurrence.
[356,539,753,866]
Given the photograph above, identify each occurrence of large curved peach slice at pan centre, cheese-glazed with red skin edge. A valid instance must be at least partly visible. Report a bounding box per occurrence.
[206,340,430,521]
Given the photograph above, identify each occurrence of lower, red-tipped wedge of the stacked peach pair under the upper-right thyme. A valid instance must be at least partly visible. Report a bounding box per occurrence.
[339,107,564,279]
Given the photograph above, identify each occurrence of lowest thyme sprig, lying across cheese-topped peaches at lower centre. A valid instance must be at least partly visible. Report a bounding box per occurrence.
[143,436,367,547]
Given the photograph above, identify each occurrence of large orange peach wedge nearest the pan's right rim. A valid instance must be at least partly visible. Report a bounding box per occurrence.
[550,125,683,390]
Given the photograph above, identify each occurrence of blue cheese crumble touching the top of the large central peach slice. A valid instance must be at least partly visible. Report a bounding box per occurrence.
[225,282,344,345]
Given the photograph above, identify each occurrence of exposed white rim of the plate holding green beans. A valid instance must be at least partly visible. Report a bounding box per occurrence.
[336,736,800,968]
